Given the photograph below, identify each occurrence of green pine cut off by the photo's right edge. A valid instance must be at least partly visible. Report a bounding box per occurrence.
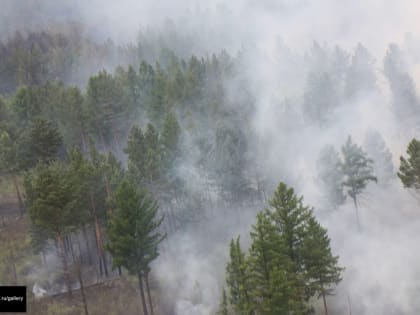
[398,139,420,193]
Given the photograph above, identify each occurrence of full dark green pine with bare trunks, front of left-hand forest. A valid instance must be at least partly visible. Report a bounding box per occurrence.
[107,180,163,315]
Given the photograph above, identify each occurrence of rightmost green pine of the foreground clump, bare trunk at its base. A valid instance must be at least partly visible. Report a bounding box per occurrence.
[302,217,343,315]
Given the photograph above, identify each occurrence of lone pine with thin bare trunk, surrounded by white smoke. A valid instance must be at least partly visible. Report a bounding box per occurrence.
[341,136,377,228]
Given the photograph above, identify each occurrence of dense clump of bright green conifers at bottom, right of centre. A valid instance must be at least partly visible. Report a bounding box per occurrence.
[222,183,343,315]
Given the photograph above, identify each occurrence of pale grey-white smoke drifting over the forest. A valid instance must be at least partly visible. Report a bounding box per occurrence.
[0,0,420,315]
